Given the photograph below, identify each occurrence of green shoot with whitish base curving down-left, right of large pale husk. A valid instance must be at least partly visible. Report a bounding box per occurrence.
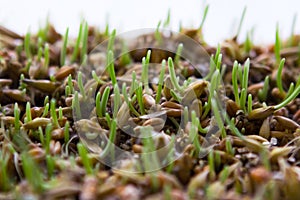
[100,119,117,158]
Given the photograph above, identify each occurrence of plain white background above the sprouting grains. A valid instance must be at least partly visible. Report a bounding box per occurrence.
[0,0,300,45]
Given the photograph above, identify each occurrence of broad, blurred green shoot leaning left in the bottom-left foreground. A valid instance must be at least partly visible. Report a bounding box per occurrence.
[21,153,44,192]
